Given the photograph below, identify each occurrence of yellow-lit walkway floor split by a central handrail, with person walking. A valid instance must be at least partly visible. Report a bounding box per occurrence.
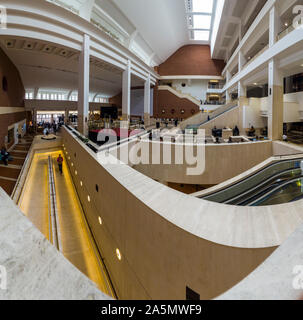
[19,150,112,296]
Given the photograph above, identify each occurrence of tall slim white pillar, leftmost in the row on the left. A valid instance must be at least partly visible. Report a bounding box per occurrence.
[78,35,90,136]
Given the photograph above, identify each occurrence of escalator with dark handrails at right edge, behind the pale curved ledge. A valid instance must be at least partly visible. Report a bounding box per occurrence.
[202,159,303,206]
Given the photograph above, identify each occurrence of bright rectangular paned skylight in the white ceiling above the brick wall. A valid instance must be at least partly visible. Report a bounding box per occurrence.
[185,0,217,43]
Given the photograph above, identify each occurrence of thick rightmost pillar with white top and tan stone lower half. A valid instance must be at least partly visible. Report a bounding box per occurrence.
[268,59,284,140]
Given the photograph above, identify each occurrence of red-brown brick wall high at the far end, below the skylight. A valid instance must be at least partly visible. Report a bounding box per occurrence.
[157,45,225,76]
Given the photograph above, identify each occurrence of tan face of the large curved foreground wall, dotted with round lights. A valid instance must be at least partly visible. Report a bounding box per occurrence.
[63,130,275,300]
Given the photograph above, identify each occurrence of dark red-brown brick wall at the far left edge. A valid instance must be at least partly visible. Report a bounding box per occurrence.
[0,49,26,147]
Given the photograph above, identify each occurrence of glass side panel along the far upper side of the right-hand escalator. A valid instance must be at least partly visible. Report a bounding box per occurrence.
[203,159,302,203]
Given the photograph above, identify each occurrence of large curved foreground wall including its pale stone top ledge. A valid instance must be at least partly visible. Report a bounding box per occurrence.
[63,129,288,299]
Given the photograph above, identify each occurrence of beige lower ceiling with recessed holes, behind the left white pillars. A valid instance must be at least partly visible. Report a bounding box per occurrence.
[0,37,143,97]
